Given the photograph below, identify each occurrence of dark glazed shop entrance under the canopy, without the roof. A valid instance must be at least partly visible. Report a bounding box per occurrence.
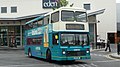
[0,26,20,47]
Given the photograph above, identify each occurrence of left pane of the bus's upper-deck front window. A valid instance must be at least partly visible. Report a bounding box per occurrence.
[61,10,74,21]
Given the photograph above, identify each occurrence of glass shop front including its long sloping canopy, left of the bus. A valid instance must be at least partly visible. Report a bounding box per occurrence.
[0,13,46,47]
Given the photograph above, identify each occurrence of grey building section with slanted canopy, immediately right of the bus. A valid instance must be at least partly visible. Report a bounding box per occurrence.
[88,9,105,49]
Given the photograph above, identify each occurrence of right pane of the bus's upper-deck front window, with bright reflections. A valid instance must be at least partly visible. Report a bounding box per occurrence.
[75,11,87,22]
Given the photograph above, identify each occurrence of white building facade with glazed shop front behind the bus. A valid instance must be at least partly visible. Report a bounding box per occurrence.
[0,0,117,46]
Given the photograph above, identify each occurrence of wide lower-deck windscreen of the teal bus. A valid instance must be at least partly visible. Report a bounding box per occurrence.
[60,34,89,46]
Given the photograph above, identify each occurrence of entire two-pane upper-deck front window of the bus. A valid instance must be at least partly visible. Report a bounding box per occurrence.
[61,10,87,22]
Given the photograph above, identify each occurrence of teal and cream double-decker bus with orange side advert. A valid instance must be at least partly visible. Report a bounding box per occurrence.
[24,7,91,61]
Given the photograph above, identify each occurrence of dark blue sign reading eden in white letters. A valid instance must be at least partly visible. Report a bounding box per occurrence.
[42,0,58,8]
